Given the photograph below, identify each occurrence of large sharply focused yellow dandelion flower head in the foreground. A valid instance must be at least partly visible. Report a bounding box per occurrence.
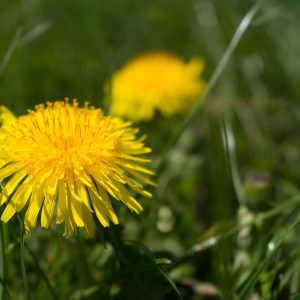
[0,100,153,236]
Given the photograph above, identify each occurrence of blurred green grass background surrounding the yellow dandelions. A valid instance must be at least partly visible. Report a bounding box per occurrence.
[0,0,300,300]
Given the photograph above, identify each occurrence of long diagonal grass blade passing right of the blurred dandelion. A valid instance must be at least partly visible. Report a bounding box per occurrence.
[155,0,265,173]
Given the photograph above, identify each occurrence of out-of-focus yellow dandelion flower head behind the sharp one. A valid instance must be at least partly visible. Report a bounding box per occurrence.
[110,52,206,121]
